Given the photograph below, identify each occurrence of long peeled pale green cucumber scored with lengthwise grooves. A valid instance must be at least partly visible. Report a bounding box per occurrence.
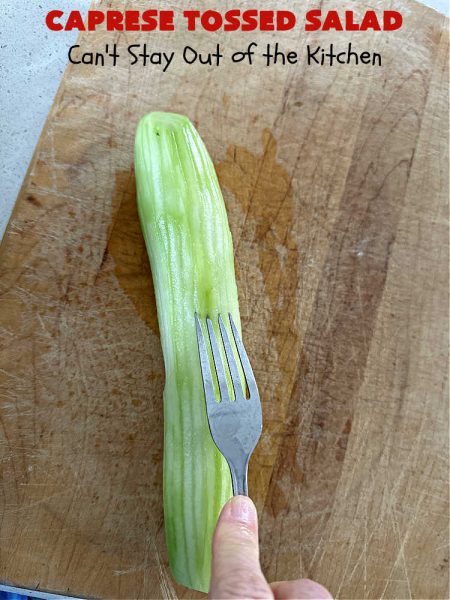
[135,112,240,592]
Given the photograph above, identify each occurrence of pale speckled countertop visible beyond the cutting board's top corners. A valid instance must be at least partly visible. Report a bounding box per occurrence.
[0,0,449,239]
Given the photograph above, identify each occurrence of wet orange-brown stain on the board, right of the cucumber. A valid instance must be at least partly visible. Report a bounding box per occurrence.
[217,129,300,506]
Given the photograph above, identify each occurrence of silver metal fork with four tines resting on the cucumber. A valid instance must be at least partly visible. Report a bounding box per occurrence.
[195,313,262,496]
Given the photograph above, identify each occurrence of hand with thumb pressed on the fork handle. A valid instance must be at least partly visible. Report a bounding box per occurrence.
[209,496,332,600]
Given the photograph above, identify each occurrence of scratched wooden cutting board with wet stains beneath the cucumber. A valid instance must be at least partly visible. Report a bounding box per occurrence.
[0,0,449,599]
